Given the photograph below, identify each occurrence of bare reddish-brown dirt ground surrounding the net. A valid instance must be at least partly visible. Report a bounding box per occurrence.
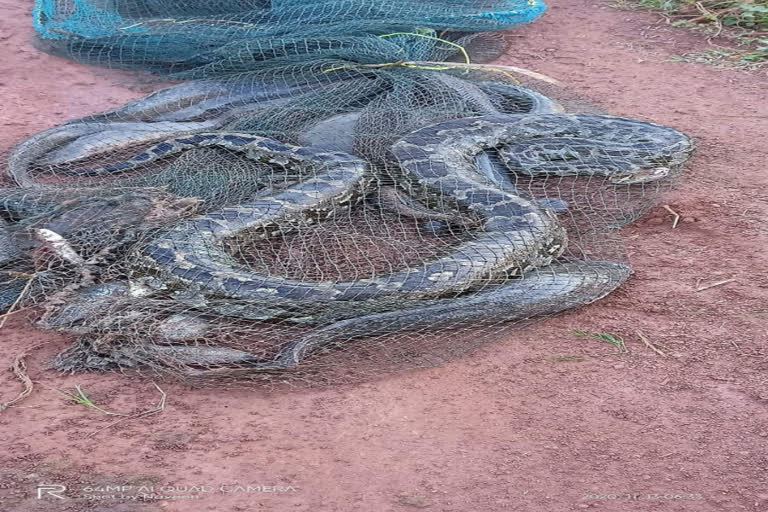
[0,0,768,512]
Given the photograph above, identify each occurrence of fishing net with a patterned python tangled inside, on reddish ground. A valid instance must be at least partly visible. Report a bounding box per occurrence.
[0,0,693,383]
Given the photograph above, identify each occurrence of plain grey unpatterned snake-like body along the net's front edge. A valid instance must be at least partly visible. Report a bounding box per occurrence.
[190,261,631,378]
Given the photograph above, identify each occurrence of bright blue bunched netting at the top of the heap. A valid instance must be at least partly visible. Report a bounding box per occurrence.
[33,0,545,78]
